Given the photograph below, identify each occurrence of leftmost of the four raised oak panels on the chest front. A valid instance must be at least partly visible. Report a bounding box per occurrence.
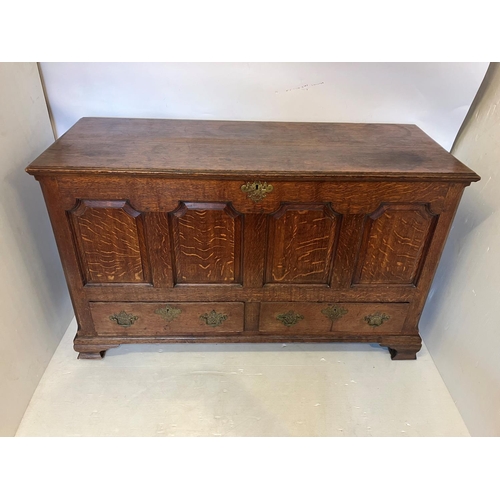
[69,200,150,284]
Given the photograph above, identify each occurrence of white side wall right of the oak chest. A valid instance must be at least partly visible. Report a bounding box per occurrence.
[420,63,500,436]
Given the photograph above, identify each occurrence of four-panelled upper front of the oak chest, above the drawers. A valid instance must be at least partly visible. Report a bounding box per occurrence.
[61,179,447,293]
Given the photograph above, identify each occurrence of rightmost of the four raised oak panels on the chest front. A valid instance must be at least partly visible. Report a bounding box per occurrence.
[353,204,438,285]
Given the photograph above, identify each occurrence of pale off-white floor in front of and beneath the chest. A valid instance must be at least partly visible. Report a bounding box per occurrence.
[17,322,469,436]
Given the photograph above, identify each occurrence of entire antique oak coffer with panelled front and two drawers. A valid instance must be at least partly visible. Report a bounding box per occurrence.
[27,118,479,359]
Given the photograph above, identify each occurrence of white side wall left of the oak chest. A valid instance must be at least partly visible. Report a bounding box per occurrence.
[0,63,72,436]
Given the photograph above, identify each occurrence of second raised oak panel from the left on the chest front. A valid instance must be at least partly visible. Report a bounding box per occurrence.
[171,203,242,284]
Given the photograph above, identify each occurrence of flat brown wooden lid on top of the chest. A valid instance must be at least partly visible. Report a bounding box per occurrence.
[28,118,478,182]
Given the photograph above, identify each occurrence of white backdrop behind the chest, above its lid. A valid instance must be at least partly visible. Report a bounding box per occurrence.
[41,63,488,151]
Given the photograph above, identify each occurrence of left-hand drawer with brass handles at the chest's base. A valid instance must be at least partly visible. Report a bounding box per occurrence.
[90,302,244,336]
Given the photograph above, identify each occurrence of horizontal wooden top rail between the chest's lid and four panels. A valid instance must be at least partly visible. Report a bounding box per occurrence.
[49,177,450,215]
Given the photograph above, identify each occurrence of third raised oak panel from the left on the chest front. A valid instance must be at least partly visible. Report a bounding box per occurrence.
[266,204,341,284]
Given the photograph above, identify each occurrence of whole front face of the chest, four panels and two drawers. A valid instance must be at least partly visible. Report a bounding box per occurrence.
[55,177,454,336]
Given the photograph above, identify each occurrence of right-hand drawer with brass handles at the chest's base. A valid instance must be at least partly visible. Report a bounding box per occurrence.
[259,302,409,334]
